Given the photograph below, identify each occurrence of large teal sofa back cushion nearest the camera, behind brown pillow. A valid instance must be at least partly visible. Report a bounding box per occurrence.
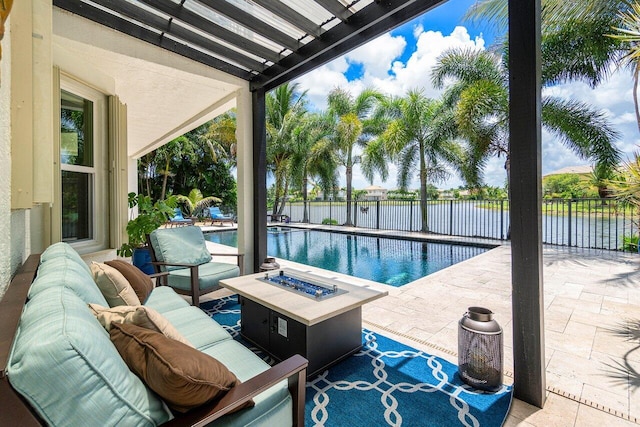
[8,287,170,427]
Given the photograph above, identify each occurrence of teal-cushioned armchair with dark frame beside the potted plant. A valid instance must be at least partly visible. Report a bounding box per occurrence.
[148,226,244,306]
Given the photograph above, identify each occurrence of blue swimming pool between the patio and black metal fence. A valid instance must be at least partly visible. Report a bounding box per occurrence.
[205,227,488,287]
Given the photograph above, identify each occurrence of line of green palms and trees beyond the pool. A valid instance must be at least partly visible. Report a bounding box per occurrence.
[140,0,640,231]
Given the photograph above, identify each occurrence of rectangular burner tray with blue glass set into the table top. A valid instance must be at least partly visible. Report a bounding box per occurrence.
[258,269,349,300]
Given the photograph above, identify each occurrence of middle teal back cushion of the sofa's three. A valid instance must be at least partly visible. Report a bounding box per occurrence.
[29,256,109,306]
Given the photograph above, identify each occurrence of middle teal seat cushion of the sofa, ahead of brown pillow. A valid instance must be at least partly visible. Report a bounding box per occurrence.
[163,306,233,350]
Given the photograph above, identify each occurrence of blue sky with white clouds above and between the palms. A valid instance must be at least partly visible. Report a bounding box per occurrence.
[297,0,640,189]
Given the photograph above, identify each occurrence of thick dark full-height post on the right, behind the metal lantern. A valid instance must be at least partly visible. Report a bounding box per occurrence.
[509,0,546,408]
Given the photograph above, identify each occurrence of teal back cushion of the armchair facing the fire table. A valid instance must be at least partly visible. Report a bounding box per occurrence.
[149,226,211,270]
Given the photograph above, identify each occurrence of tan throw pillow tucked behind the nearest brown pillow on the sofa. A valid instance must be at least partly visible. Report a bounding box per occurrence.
[89,304,193,347]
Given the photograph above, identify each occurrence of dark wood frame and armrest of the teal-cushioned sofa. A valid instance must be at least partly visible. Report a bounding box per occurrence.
[0,255,308,427]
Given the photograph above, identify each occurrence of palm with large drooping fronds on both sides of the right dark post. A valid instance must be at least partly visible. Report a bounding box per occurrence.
[432,49,620,189]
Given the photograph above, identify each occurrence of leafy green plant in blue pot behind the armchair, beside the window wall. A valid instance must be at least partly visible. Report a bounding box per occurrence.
[118,193,178,274]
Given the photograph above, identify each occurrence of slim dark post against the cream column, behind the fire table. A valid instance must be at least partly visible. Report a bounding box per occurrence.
[251,89,267,272]
